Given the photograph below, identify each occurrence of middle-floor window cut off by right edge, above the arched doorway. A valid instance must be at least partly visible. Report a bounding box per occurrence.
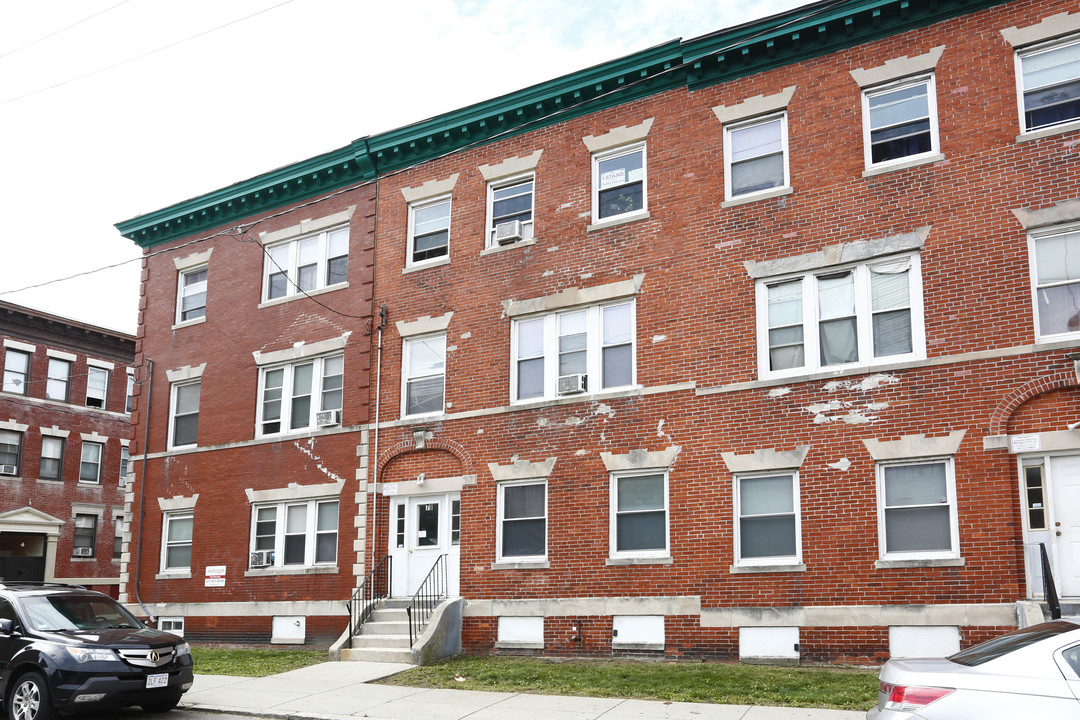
[1029,227,1080,340]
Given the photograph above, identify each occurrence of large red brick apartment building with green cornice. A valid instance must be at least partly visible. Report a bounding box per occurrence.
[118,0,1080,661]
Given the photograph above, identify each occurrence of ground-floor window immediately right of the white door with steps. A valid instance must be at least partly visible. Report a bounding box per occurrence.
[496,480,548,561]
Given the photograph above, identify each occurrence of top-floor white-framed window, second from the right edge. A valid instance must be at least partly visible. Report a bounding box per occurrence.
[863,78,937,167]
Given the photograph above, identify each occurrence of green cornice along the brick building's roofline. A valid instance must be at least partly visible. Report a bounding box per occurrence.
[117,0,1008,248]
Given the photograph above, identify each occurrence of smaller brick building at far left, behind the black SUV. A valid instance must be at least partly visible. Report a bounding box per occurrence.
[0,302,135,597]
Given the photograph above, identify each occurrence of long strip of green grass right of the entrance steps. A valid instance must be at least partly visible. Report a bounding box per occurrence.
[380,656,878,710]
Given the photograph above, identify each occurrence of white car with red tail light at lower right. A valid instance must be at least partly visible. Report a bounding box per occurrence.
[866,617,1080,720]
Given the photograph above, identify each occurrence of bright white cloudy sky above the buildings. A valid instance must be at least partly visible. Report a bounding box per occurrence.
[0,0,807,332]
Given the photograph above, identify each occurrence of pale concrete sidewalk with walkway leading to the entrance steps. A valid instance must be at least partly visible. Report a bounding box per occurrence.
[180,662,865,720]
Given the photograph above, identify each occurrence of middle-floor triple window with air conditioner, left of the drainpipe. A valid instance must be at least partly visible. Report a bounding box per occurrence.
[258,355,345,435]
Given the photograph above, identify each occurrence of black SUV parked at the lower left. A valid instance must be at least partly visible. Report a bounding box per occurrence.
[0,582,193,720]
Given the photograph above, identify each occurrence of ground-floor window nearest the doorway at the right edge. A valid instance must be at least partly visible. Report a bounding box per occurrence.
[877,460,959,559]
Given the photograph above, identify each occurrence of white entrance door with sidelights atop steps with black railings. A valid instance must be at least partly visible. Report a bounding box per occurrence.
[390,492,461,597]
